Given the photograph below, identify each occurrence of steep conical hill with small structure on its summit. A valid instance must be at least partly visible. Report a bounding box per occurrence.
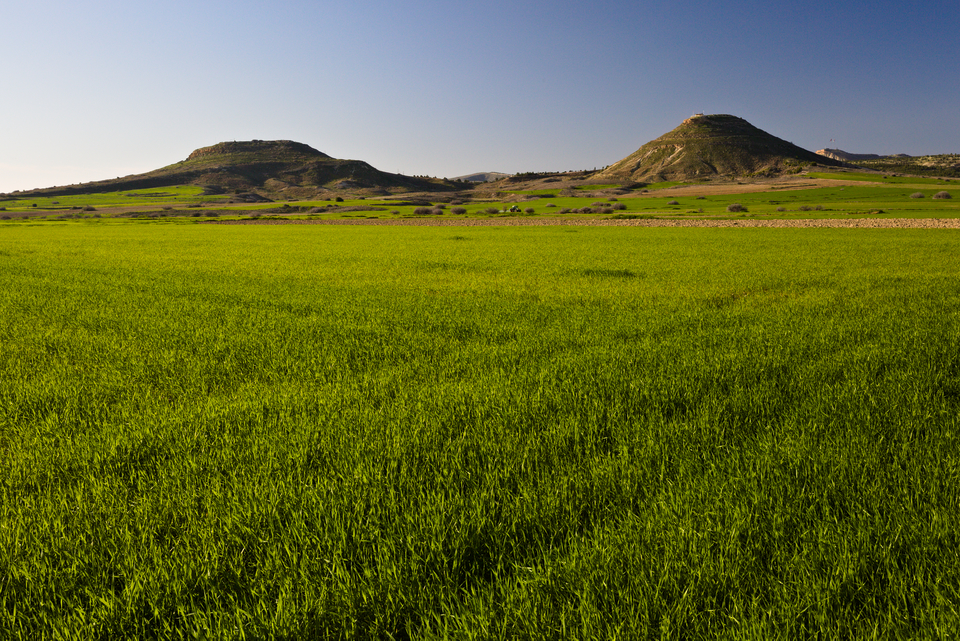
[595,114,843,182]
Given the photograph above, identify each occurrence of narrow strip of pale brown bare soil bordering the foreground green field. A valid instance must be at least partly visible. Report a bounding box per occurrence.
[209,217,960,229]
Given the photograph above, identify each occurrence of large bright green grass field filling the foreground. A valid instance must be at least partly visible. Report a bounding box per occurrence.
[0,224,960,639]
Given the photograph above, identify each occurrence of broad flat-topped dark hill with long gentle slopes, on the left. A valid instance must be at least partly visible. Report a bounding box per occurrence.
[14,140,457,198]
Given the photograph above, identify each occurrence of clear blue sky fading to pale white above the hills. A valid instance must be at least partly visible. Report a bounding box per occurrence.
[0,0,960,192]
